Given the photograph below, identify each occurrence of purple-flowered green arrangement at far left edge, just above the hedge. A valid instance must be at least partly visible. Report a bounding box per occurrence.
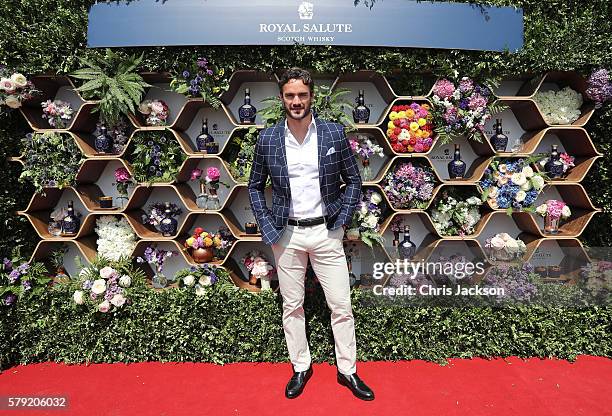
[0,248,51,306]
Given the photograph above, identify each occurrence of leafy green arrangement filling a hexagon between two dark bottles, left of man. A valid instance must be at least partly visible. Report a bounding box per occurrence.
[130,131,186,182]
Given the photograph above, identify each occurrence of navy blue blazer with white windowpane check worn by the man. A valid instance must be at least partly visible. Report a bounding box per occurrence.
[248,117,361,244]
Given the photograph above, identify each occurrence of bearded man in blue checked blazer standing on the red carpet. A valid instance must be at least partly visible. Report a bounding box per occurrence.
[248,68,374,400]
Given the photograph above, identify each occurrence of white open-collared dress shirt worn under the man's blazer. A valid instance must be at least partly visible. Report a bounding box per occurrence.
[285,117,327,219]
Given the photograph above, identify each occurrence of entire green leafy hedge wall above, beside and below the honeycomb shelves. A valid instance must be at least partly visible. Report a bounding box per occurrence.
[0,0,612,367]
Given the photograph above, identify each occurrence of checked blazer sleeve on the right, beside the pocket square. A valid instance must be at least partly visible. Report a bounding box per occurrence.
[338,124,362,225]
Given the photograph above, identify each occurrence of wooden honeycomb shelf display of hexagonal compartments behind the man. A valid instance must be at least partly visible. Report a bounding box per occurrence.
[12,70,602,291]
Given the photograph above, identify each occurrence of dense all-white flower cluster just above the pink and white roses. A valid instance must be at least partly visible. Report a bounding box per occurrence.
[95,215,137,261]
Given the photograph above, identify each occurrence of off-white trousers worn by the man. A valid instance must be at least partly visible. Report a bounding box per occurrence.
[272,224,357,374]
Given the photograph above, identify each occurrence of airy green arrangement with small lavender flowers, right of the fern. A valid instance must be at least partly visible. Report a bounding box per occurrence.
[170,58,229,108]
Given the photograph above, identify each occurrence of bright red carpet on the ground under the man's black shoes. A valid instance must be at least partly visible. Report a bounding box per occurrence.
[0,356,612,416]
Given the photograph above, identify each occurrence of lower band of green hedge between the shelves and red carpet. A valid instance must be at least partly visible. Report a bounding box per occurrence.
[0,283,612,368]
